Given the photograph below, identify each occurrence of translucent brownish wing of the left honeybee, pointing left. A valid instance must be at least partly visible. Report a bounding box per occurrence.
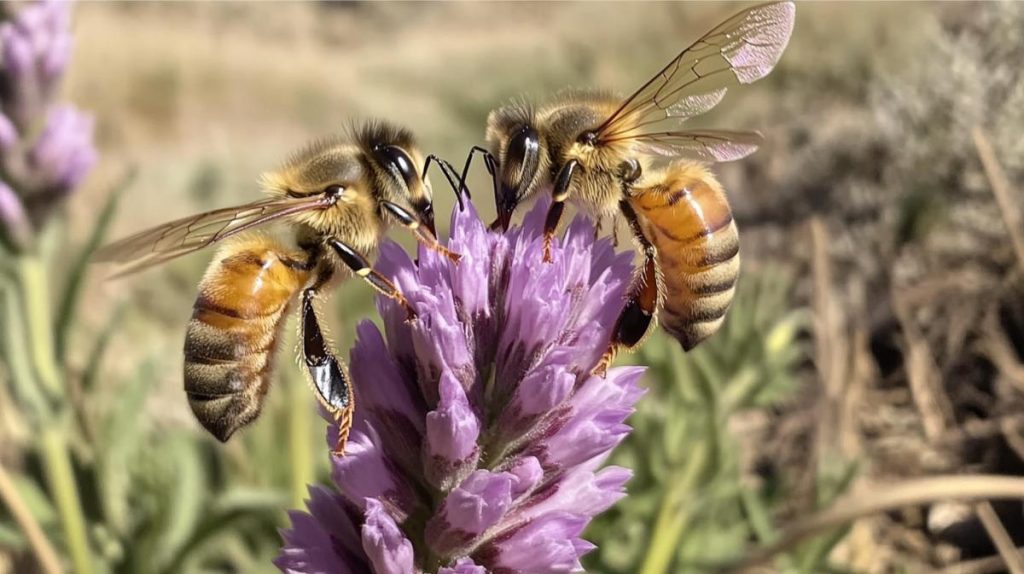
[93,194,336,277]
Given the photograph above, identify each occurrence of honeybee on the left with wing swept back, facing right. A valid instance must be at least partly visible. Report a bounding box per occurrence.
[97,122,459,454]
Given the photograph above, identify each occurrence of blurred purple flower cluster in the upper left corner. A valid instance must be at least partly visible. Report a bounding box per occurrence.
[0,0,96,248]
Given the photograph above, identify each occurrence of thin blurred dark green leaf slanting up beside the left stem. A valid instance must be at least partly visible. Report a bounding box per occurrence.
[55,170,135,365]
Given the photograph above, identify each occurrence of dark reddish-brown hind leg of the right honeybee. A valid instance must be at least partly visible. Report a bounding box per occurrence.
[592,200,659,377]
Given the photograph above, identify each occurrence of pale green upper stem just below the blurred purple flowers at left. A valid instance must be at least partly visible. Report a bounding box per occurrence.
[17,255,65,398]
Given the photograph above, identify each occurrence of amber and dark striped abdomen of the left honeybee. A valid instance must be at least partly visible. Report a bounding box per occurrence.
[184,236,309,441]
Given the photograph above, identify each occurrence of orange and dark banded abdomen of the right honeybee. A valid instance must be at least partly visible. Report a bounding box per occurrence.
[631,163,739,351]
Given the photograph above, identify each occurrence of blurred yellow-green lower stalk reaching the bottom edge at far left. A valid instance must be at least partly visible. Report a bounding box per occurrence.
[39,428,93,574]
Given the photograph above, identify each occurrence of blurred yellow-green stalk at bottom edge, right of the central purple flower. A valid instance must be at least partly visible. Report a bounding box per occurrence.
[640,442,710,574]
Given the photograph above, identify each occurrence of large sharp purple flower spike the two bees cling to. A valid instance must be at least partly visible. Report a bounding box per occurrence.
[276,194,643,574]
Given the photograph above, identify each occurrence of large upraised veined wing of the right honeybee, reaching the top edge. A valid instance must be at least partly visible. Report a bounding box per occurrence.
[597,1,797,141]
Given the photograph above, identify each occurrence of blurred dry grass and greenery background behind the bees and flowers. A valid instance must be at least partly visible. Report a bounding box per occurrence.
[0,2,1024,574]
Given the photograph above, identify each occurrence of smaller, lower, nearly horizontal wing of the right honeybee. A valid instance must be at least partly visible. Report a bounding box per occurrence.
[624,130,764,162]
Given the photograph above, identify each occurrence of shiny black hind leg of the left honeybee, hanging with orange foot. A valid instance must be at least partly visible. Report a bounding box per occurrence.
[301,281,355,456]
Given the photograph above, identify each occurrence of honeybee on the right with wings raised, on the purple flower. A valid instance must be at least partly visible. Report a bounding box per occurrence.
[475,1,796,372]
